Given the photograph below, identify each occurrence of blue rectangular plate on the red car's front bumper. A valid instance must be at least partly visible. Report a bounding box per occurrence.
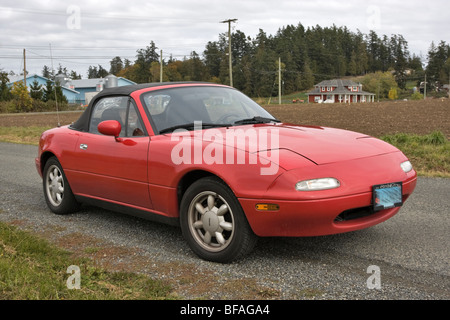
[372,182,403,211]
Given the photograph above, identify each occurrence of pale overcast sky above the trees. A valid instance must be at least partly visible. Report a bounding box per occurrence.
[0,0,450,78]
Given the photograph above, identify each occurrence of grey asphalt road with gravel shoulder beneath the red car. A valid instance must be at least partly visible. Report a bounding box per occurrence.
[0,143,450,300]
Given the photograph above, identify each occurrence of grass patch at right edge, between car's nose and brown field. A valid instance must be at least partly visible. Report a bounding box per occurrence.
[381,131,450,178]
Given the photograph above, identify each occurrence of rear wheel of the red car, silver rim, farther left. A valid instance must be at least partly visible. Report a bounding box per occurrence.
[42,157,79,214]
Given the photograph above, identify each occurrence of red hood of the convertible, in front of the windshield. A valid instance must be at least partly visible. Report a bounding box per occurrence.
[204,124,398,167]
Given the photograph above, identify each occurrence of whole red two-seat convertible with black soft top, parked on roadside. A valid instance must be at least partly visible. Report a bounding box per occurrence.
[36,82,417,263]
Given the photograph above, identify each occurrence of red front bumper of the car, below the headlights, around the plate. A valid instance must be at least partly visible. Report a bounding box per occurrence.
[239,175,417,237]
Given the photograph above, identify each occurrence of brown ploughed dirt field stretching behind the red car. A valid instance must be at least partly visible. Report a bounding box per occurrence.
[0,99,450,138]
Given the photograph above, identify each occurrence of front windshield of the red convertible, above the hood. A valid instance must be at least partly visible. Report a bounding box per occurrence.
[142,86,278,133]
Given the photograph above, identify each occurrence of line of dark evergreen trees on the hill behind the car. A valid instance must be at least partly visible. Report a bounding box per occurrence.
[0,24,450,105]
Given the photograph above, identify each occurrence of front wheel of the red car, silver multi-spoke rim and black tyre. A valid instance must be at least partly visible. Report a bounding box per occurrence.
[180,177,257,263]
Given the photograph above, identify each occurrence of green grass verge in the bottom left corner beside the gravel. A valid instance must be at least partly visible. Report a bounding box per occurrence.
[0,223,174,300]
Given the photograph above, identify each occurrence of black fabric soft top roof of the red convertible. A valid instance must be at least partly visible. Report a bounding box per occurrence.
[70,82,213,132]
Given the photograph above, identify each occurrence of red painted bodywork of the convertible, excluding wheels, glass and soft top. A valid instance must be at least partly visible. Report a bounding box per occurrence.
[36,84,417,237]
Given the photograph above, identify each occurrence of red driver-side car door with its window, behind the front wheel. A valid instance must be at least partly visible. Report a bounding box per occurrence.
[70,96,152,209]
